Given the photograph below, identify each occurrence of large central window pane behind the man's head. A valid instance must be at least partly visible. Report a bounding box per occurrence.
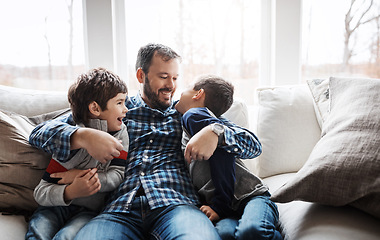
[125,0,260,104]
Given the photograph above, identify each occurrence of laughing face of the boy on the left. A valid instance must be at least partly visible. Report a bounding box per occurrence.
[99,93,128,132]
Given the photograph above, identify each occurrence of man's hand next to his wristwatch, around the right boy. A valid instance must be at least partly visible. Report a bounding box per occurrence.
[185,126,218,163]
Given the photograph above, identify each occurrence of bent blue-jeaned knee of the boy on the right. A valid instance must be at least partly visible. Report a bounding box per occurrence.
[226,193,283,240]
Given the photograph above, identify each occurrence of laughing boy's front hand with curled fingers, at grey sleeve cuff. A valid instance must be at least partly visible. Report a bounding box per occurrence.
[64,168,101,202]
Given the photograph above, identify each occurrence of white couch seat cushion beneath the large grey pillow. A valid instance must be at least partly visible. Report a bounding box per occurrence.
[263,173,380,240]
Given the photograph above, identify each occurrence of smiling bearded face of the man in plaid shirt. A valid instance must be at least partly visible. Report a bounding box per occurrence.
[142,54,179,110]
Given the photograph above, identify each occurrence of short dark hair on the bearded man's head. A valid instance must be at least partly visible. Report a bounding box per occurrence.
[135,43,181,74]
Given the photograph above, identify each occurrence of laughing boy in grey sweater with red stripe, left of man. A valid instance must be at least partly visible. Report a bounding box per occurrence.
[26,68,129,239]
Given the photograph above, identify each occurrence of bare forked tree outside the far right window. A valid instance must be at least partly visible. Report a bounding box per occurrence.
[342,0,380,71]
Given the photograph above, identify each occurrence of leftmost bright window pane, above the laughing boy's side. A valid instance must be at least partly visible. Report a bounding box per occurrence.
[0,0,85,90]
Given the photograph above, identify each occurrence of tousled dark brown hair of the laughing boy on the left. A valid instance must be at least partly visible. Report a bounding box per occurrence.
[67,67,128,125]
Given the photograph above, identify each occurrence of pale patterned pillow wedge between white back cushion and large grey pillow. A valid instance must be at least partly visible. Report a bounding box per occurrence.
[307,79,330,129]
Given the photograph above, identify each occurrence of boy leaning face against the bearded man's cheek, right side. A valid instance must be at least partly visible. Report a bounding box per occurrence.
[175,75,282,239]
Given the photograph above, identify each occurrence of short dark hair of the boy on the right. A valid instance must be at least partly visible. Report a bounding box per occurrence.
[193,75,234,117]
